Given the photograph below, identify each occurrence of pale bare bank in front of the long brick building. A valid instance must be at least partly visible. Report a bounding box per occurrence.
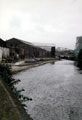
[12,58,59,73]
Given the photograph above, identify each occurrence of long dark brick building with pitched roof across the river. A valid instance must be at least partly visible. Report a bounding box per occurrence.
[6,38,47,59]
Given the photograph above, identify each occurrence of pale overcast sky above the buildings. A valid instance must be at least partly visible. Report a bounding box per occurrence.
[0,0,82,49]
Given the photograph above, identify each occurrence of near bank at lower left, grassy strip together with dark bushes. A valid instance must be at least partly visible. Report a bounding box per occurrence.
[0,63,32,120]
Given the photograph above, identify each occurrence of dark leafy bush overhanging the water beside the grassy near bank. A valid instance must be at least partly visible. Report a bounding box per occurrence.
[0,63,32,103]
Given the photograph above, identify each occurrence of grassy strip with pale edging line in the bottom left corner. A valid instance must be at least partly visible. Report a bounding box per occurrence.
[0,78,32,120]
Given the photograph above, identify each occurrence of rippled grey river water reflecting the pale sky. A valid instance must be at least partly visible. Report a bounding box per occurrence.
[14,60,82,120]
